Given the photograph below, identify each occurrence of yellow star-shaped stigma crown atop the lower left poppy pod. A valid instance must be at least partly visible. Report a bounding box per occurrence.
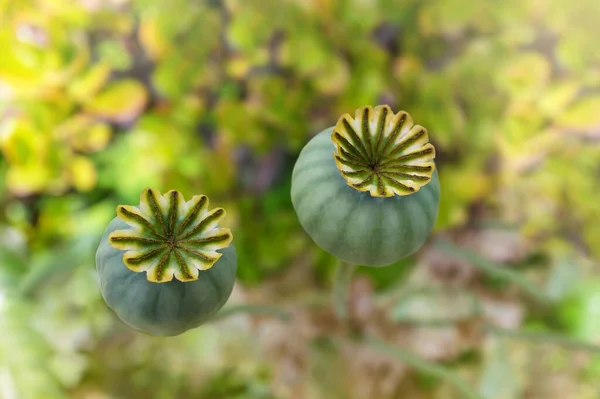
[108,188,233,283]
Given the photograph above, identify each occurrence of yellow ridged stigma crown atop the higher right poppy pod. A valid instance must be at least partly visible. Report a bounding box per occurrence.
[331,105,435,197]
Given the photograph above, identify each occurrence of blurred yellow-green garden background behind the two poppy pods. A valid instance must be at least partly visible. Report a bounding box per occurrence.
[0,0,600,399]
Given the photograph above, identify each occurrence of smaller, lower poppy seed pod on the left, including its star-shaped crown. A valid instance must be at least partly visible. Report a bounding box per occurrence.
[96,189,237,336]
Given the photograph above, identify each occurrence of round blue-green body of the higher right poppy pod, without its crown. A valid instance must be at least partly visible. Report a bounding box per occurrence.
[291,127,440,267]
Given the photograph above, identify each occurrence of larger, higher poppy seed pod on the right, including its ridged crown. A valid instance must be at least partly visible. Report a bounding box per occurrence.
[291,105,440,266]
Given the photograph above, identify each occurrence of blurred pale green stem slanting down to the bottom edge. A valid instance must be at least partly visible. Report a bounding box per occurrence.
[366,338,481,399]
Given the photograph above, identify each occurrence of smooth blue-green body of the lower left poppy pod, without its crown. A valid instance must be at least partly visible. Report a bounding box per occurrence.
[96,218,237,336]
